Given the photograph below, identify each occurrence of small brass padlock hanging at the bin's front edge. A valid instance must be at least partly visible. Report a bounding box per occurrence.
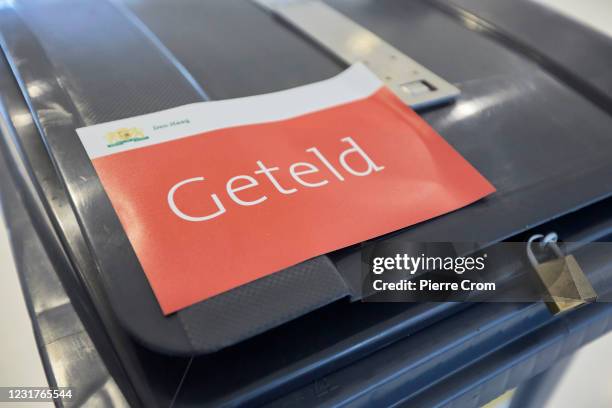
[527,232,597,314]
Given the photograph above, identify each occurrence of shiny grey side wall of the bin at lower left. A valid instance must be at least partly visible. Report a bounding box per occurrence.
[0,136,129,408]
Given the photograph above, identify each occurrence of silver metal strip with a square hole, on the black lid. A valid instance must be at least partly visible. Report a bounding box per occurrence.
[253,0,460,109]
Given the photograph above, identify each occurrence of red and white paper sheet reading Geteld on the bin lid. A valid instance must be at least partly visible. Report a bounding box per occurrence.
[79,63,495,314]
